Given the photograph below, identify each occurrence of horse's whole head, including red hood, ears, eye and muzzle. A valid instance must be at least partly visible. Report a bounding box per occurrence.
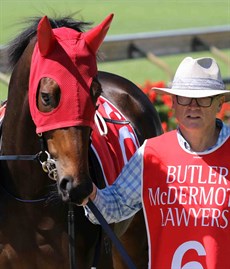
[29,15,113,203]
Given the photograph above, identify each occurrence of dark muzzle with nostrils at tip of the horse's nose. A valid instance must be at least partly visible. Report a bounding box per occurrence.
[58,176,93,205]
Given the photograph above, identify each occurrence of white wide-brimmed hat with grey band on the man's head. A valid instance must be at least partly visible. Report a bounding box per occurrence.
[153,57,230,101]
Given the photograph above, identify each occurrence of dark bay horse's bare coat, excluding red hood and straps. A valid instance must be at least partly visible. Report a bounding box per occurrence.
[0,16,162,269]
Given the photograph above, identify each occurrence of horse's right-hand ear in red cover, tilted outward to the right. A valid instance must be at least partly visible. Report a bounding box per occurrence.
[84,14,113,54]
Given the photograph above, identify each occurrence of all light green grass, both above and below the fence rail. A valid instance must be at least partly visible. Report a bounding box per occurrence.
[0,0,230,99]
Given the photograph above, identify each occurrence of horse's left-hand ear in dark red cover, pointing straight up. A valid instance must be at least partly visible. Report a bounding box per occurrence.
[37,16,56,56]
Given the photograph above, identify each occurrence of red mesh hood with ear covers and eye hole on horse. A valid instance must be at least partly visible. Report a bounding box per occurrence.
[29,14,113,133]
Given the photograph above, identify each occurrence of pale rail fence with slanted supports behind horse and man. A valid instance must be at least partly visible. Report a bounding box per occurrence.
[0,25,230,84]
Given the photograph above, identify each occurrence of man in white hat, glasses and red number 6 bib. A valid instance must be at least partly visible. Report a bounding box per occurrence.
[85,57,230,269]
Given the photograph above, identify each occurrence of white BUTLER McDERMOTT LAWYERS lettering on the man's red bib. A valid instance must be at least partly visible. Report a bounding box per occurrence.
[148,165,230,229]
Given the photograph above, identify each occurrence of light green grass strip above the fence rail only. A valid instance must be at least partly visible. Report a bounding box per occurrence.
[0,0,230,43]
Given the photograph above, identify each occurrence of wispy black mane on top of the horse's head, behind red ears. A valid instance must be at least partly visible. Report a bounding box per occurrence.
[7,14,92,68]
